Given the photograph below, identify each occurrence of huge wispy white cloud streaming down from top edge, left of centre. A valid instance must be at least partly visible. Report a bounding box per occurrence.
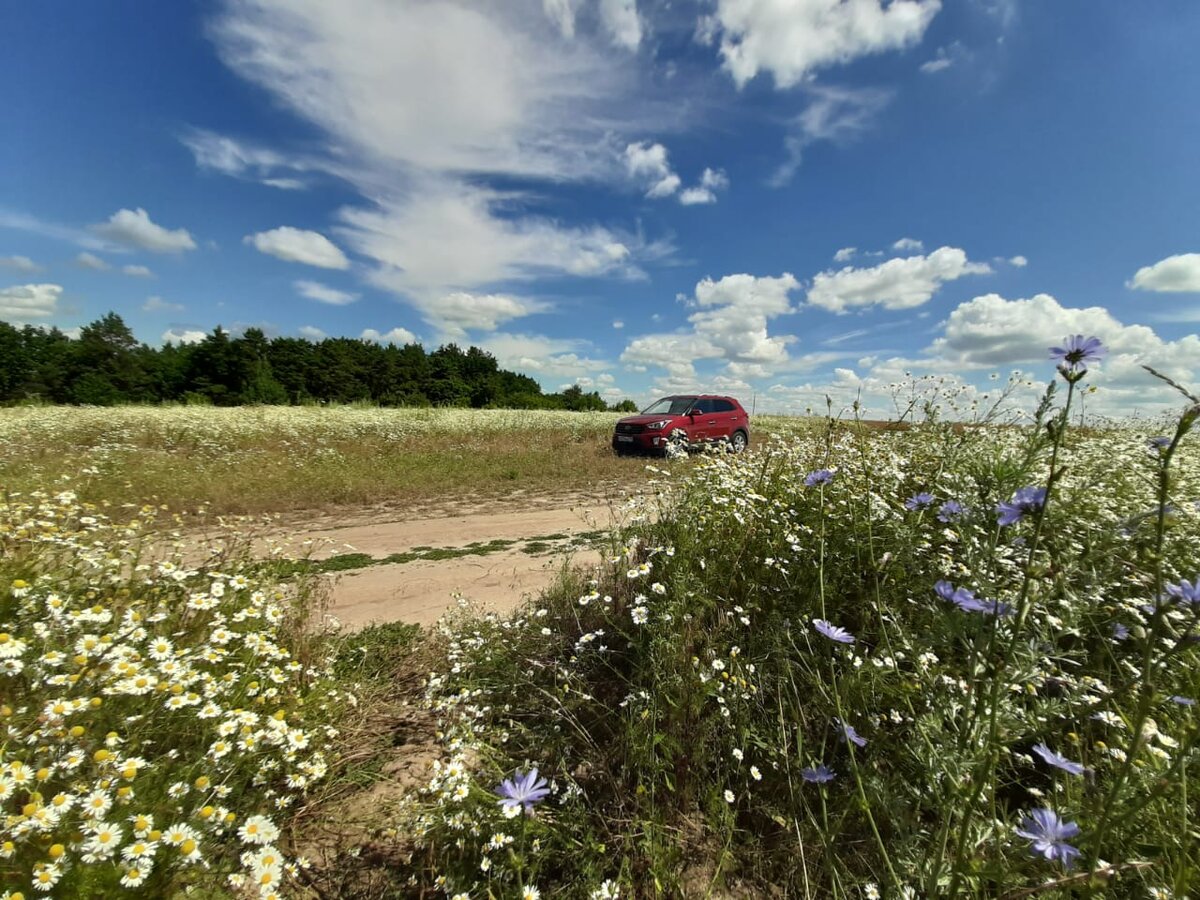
[211,0,694,331]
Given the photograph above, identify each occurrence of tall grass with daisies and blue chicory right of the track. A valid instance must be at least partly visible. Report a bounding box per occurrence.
[398,355,1200,898]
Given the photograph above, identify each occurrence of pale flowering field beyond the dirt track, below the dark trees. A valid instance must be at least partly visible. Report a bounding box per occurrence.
[0,407,806,514]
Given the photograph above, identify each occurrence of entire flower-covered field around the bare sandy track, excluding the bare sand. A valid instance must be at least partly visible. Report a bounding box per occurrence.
[0,382,1200,900]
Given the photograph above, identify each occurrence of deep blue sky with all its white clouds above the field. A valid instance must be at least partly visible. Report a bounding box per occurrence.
[0,0,1200,415]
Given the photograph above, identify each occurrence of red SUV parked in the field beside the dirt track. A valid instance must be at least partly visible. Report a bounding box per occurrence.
[612,394,750,455]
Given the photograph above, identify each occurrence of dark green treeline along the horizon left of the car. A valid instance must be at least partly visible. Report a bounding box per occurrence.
[0,312,636,410]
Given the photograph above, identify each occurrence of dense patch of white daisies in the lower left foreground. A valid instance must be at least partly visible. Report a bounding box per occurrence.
[0,492,337,898]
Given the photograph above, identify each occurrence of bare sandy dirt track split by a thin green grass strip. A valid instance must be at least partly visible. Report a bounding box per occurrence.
[302,498,616,628]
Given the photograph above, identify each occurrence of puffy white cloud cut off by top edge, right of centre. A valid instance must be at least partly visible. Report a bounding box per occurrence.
[706,0,941,88]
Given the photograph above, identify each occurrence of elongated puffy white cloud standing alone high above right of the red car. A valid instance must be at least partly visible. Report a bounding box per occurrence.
[808,247,991,313]
